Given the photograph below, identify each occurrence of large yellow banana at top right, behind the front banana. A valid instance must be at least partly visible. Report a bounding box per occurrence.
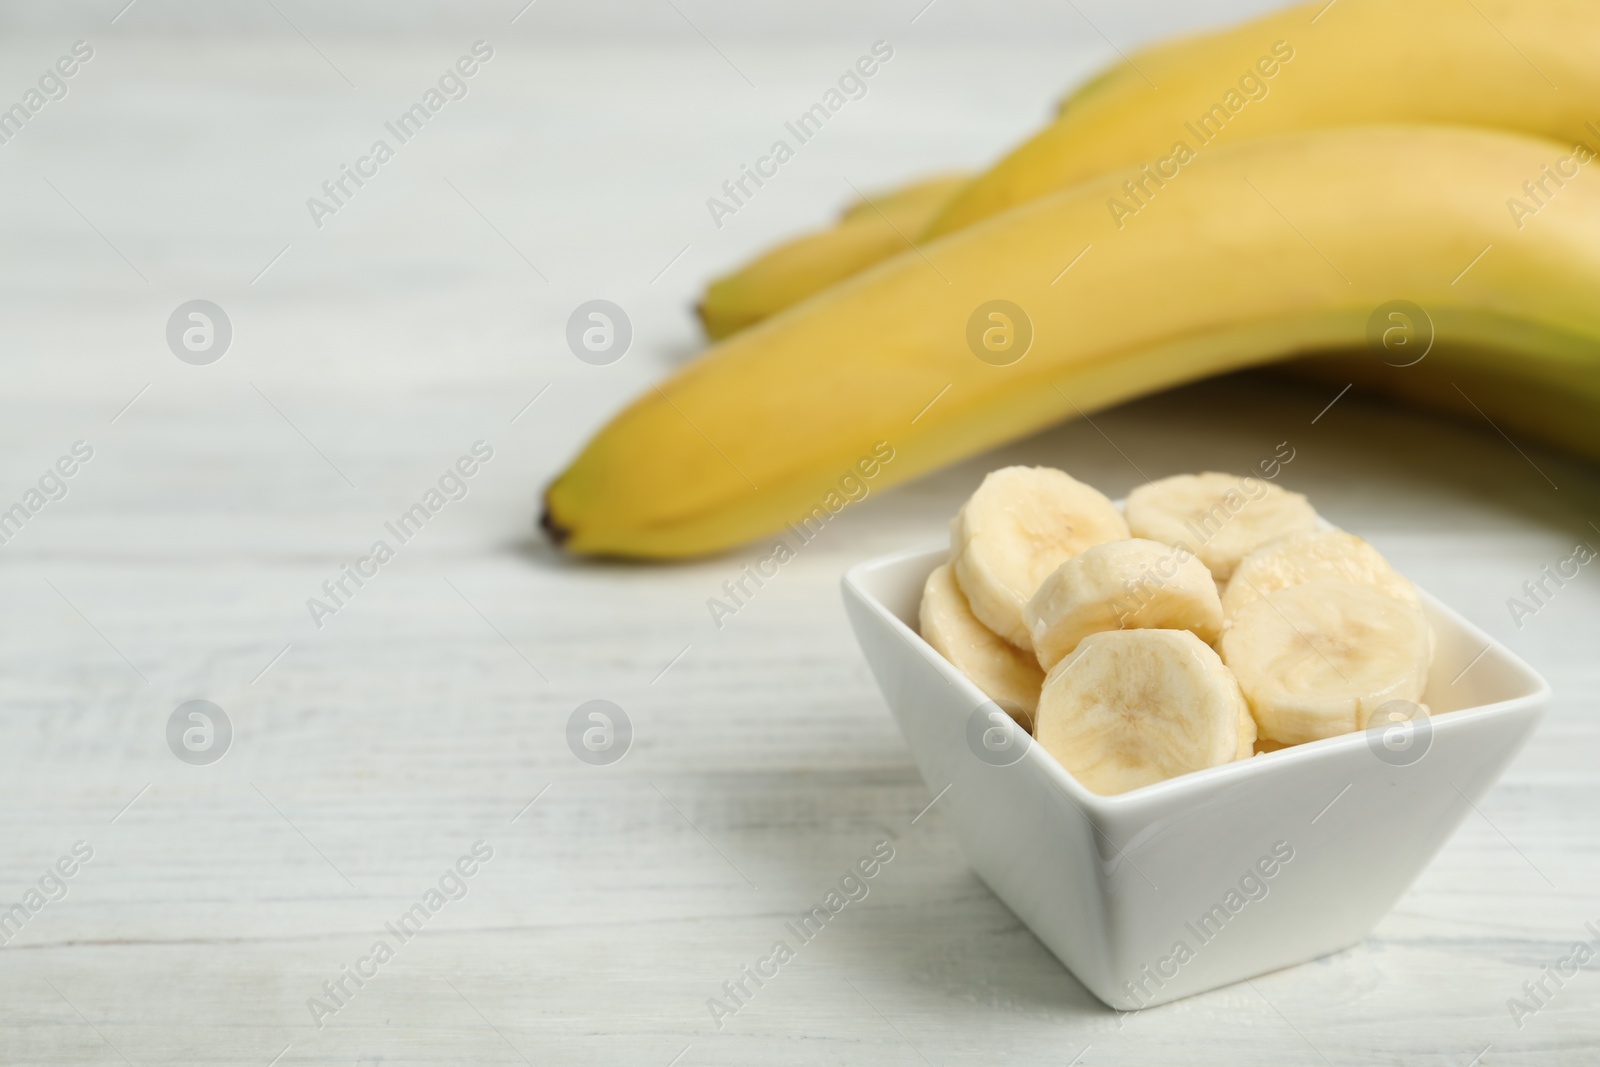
[918,0,1600,240]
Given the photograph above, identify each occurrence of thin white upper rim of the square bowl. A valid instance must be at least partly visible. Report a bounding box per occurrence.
[840,537,1552,817]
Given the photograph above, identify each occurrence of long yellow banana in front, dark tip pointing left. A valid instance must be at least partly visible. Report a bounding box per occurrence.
[542,126,1600,557]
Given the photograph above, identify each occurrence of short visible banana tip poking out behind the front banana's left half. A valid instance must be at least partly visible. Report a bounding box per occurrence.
[694,174,966,341]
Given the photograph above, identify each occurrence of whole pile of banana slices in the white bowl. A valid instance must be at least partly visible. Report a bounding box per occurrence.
[920,467,1434,793]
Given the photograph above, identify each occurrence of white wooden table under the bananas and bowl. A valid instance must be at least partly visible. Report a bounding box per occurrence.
[0,14,1600,1067]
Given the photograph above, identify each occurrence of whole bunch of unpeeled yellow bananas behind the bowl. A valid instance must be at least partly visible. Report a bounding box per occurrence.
[542,0,1600,558]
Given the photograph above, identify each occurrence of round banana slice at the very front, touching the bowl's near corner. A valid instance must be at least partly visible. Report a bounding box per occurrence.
[1034,630,1256,795]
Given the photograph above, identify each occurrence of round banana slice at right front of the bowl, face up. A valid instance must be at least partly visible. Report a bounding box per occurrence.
[1216,581,1432,744]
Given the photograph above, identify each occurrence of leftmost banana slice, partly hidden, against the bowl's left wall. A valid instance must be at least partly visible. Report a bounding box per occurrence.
[920,563,1045,731]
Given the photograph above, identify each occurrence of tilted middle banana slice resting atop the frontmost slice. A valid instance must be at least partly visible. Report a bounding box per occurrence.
[1022,537,1222,670]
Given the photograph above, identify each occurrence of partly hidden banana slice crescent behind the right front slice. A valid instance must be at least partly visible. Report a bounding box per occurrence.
[1222,530,1421,619]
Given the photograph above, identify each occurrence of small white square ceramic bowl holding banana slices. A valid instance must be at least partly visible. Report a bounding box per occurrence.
[843,542,1550,1009]
